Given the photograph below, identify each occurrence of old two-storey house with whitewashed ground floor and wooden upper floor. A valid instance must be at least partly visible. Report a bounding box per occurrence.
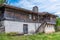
[0,4,56,34]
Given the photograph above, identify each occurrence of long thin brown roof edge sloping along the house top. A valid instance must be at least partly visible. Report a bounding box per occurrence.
[0,4,57,17]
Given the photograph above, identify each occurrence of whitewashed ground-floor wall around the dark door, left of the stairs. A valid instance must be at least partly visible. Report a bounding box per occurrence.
[4,20,41,34]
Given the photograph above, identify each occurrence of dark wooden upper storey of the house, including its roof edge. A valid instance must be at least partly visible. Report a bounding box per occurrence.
[0,5,56,23]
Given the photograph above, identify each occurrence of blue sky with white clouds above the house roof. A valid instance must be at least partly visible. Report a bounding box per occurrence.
[8,0,60,17]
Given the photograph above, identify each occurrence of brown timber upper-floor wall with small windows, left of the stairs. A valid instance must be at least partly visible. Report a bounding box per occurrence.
[4,8,38,22]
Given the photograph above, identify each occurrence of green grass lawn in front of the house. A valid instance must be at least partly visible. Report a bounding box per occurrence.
[0,32,60,40]
